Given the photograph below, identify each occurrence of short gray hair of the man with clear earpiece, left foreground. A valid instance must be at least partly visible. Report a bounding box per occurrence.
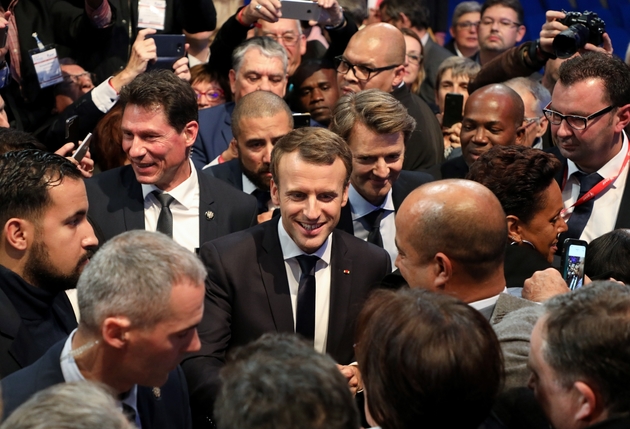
[77,230,206,333]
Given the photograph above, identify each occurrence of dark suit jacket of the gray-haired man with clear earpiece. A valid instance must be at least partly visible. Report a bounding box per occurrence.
[2,340,192,429]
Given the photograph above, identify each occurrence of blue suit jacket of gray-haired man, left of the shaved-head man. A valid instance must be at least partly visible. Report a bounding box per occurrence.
[192,101,236,169]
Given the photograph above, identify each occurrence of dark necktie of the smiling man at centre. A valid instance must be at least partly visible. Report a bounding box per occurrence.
[295,255,319,341]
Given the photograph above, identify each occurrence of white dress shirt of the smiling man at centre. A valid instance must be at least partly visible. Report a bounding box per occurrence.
[278,219,332,353]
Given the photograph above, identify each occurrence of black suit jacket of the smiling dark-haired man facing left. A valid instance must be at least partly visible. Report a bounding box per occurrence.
[85,165,258,247]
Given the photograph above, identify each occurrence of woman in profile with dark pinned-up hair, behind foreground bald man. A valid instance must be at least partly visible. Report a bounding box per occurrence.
[467,146,567,287]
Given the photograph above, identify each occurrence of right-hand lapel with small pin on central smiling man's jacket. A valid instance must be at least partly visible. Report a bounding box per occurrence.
[326,231,353,355]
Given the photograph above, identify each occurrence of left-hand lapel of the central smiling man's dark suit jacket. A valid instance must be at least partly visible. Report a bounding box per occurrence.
[258,218,295,332]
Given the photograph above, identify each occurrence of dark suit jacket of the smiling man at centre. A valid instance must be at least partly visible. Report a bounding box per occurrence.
[182,218,391,427]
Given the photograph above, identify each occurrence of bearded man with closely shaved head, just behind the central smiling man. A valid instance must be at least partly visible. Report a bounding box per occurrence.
[204,91,293,223]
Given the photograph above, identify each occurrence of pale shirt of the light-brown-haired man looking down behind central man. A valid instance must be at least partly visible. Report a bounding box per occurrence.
[348,184,398,271]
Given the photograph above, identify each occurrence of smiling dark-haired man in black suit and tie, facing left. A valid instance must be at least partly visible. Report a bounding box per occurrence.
[86,70,257,251]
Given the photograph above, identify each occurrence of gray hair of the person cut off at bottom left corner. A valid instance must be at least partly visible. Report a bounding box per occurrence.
[0,381,135,429]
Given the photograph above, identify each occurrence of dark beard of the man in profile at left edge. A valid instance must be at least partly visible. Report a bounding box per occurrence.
[24,241,94,293]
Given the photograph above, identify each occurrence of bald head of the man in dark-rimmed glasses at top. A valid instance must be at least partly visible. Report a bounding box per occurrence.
[338,22,405,93]
